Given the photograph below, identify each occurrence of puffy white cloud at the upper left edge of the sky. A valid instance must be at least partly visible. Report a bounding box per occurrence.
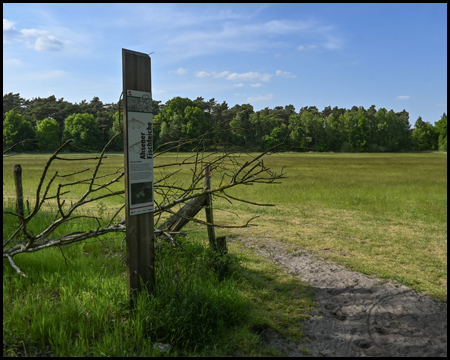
[3,19,70,52]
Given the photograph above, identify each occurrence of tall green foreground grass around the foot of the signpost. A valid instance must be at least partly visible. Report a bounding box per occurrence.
[3,205,250,356]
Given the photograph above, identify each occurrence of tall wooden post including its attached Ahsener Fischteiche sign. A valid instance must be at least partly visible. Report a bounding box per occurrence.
[122,49,155,308]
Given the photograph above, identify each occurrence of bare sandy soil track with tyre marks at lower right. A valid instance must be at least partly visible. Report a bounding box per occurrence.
[228,237,447,357]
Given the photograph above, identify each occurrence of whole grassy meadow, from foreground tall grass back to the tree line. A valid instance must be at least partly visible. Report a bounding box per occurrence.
[3,153,447,356]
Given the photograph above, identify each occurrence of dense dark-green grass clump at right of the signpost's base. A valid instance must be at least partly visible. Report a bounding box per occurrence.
[136,236,249,350]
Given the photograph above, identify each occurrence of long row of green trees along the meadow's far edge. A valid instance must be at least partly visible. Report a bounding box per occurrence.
[3,93,447,152]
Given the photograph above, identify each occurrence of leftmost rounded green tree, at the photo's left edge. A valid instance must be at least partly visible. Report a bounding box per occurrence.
[3,110,36,151]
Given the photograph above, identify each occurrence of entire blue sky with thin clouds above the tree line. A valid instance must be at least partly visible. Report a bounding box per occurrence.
[3,4,447,125]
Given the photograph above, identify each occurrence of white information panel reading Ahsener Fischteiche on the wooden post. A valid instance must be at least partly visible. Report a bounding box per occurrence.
[127,90,155,215]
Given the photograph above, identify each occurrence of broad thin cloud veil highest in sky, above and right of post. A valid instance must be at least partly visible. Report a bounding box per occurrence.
[125,5,343,60]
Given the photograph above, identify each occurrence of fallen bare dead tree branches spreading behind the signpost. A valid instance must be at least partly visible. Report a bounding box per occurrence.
[3,118,287,277]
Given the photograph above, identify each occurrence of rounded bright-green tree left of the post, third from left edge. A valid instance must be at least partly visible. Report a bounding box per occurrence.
[63,113,102,150]
